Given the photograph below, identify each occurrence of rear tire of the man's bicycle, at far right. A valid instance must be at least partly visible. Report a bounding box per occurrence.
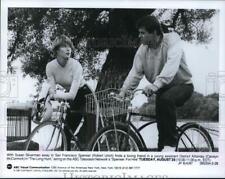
[176,123,214,152]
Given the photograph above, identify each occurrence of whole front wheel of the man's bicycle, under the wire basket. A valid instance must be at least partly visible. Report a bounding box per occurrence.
[88,124,143,151]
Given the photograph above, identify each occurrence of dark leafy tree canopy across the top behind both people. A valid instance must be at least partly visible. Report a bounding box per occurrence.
[8,8,216,79]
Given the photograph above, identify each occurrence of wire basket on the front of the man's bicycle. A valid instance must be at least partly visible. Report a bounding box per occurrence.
[85,88,130,117]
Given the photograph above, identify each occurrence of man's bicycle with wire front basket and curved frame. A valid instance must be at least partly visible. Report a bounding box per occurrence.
[87,89,214,152]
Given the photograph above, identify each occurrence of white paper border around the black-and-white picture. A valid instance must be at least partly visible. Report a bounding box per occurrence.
[0,0,225,177]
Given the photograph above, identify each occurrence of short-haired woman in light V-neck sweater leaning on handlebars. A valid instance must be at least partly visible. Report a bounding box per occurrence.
[46,35,93,150]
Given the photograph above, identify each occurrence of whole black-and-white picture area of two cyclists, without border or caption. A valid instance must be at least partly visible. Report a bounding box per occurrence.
[1,2,224,178]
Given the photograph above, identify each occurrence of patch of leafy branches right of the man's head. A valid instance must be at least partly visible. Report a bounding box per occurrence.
[154,9,215,43]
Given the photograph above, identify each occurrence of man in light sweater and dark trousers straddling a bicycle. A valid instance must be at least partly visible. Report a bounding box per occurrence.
[119,16,193,152]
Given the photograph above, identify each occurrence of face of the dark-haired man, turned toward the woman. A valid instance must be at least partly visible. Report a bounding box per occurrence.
[138,27,156,48]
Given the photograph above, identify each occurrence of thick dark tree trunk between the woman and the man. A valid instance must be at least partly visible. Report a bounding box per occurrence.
[97,9,155,91]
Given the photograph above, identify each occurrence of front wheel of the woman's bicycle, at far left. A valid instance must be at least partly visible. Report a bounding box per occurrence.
[25,121,67,151]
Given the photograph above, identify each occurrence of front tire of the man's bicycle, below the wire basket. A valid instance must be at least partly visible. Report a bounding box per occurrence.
[87,123,144,151]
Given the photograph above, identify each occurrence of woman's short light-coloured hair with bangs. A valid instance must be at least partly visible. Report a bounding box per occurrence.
[52,35,74,55]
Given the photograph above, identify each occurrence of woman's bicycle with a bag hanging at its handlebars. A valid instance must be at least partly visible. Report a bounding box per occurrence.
[25,85,99,151]
